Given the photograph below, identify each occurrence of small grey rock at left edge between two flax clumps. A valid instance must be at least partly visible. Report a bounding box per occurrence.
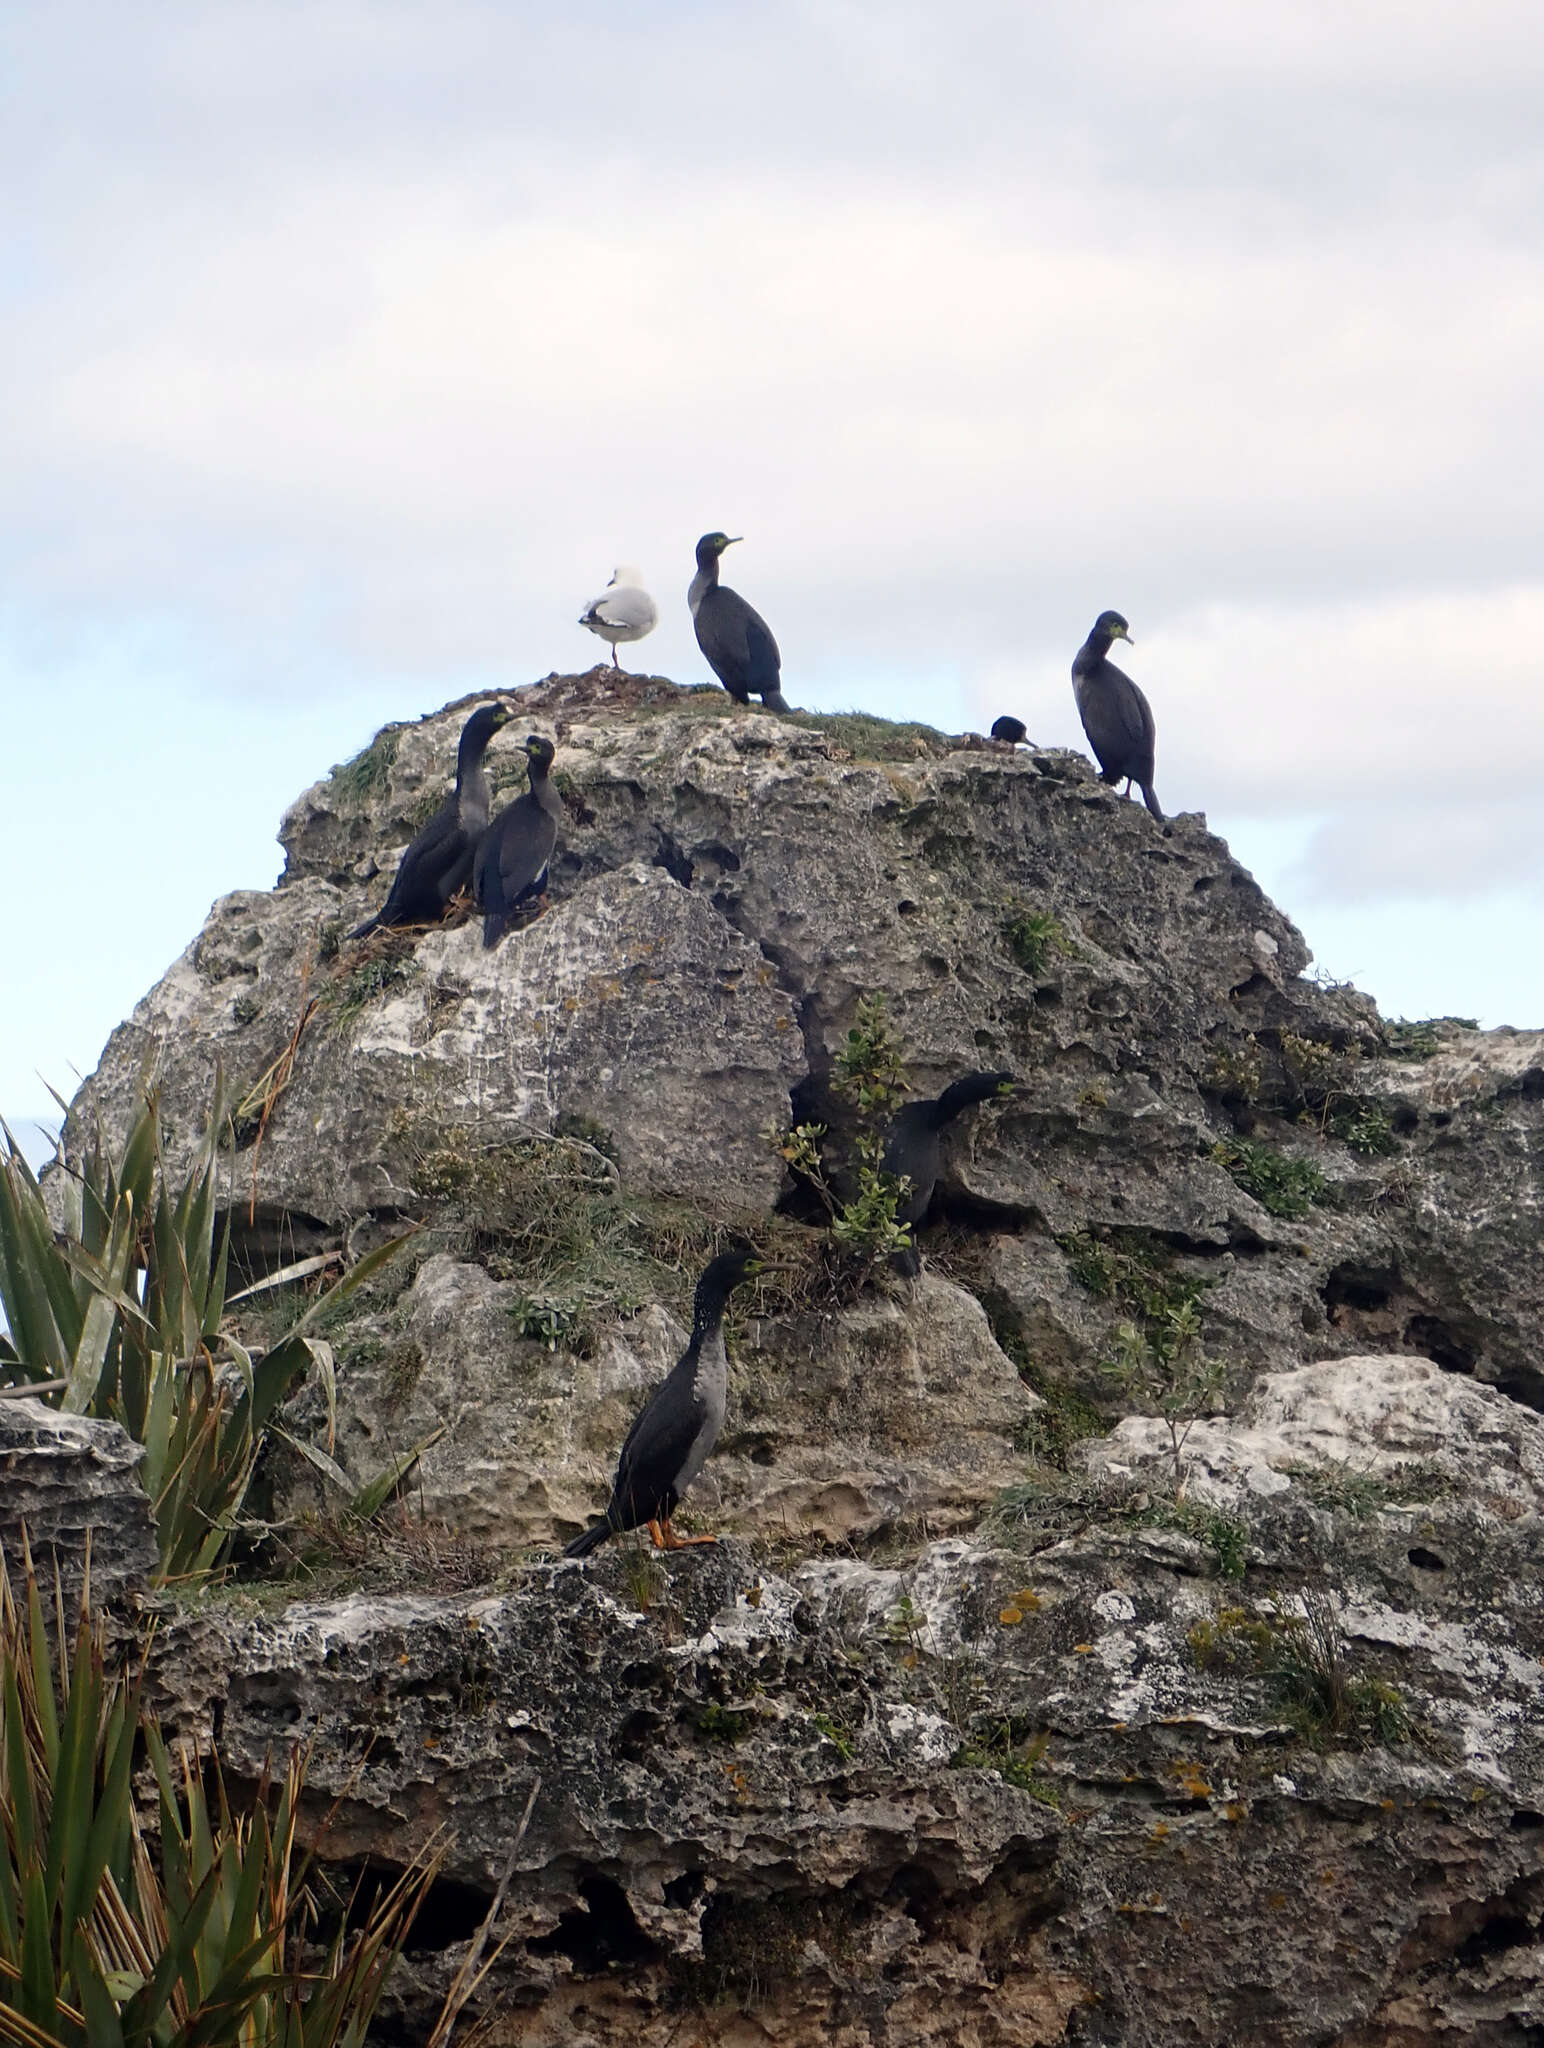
[0,1397,156,1602]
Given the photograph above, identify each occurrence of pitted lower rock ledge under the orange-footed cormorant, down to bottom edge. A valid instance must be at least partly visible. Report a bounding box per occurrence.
[150,1358,1544,2048]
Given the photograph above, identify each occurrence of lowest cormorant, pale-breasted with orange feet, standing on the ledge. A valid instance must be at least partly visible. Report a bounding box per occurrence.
[563,1245,770,1556]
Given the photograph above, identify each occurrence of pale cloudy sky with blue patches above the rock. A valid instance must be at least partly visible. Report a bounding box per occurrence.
[0,0,1544,1137]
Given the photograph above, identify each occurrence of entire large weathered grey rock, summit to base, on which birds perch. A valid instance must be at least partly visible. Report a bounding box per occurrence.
[54,676,1544,2048]
